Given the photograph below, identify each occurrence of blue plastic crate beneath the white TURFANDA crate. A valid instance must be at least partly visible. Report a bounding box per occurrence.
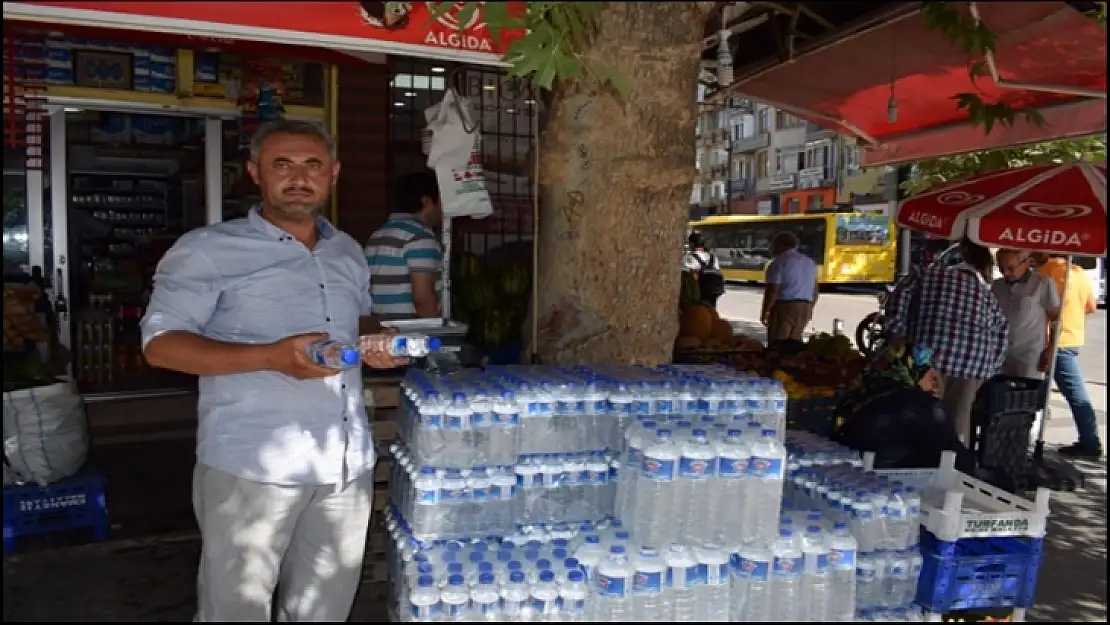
[917,530,1043,613]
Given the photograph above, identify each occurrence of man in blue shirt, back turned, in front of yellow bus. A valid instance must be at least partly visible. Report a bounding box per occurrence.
[760,232,817,345]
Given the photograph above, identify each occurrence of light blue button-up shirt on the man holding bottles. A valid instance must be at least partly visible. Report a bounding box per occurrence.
[142,209,374,485]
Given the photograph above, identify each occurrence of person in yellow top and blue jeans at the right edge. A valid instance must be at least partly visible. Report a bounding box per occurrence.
[1038,255,1102,458]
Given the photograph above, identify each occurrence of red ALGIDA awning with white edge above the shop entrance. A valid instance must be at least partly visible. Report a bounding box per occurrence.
[4,2,524,65]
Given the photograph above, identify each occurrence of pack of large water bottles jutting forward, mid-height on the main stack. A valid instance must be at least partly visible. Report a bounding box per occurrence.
[615,381,786,546]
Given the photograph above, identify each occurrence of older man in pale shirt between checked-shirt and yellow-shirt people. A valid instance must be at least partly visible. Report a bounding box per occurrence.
[990,250,1060,379]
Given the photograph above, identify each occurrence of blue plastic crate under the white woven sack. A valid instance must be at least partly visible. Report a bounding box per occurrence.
[3,467,109,553]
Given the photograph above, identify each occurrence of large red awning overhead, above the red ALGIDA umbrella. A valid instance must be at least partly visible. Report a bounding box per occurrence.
[729,2,1107,165]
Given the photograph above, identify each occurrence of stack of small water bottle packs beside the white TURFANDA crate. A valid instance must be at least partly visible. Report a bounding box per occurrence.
[776,432,924,622]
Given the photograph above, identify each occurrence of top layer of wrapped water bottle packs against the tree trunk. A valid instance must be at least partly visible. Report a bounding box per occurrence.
[398,366,786,468]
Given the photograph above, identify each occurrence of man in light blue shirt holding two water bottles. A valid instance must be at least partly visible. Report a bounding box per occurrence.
[142,121,406,622]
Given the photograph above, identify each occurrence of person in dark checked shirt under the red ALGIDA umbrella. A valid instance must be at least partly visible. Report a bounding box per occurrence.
[887,239,1010,445]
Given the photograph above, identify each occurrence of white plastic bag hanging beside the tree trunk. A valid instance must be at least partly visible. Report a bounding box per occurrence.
[424,89,493,219]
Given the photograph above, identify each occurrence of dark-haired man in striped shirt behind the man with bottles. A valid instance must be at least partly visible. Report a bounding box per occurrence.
[365,171,443,320]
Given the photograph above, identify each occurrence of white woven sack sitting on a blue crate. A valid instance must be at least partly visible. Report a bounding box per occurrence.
[3,382,89,486]
